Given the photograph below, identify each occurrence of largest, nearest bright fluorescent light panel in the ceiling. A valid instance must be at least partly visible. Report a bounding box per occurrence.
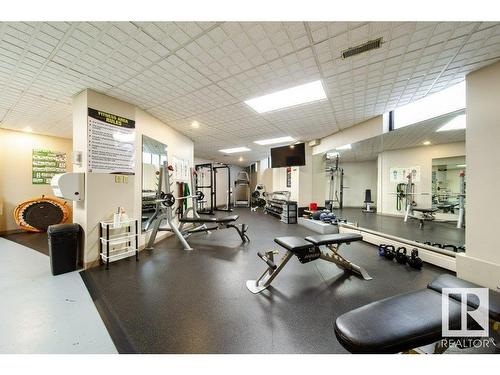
[245,81,326,113]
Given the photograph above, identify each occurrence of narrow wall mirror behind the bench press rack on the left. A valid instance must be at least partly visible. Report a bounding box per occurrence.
[141,135,167,232]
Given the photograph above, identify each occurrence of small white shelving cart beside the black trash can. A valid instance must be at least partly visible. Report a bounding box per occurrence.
[99,219,139,269]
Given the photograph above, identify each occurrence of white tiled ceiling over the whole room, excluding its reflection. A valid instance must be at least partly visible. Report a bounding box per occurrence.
[0,22,500,162]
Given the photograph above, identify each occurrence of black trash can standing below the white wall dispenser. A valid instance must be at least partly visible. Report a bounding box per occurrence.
[47,224,80,275]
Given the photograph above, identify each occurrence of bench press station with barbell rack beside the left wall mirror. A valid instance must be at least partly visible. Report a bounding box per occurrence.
[146,162,250,250]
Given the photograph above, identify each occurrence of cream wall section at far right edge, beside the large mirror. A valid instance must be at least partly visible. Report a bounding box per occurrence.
[457,62,500,289]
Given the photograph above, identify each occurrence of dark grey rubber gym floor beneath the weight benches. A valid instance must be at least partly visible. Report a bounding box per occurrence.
[82,209,446,353]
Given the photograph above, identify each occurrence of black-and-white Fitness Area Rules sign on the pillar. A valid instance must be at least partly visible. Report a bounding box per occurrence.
[88,108,135,174]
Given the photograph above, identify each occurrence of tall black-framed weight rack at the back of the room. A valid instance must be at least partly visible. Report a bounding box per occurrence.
[193,163,232,215]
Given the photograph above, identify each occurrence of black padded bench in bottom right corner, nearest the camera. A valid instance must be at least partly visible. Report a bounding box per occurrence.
[335,275,500,354]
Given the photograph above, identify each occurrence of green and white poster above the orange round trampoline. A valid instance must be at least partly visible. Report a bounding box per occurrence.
[31,149,66,185]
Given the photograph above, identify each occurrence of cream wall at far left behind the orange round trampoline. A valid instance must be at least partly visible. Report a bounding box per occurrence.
[0,129,72,231]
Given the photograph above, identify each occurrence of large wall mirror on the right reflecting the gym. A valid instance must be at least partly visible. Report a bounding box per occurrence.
[313,110,466,251]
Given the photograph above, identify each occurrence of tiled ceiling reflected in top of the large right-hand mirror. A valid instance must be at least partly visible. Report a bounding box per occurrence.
[326,111,465,162]
